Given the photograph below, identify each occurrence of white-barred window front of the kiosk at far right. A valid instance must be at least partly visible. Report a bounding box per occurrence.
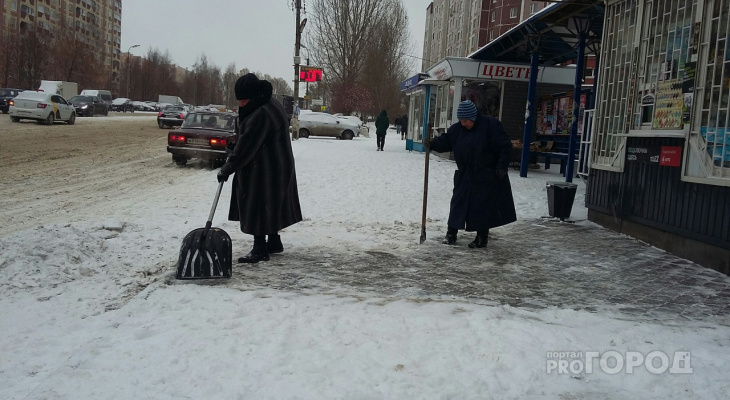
[591,0,730,186]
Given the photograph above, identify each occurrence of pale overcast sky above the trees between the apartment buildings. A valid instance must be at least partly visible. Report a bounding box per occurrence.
[121,0,430,85]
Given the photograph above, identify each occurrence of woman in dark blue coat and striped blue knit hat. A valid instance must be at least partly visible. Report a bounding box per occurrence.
[430,100,517,248]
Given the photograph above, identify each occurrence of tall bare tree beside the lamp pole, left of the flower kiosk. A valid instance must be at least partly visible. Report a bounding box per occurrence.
[306,0,411,114]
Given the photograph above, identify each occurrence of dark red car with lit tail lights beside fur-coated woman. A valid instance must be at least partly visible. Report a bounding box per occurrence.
[167,111,238,168]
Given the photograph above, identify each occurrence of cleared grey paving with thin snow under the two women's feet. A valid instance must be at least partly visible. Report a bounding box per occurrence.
[178,220,730,323]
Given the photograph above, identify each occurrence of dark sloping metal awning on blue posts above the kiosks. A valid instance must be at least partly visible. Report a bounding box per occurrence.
[467,0,604,65]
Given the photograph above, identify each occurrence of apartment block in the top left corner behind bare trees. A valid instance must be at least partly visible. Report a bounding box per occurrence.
[0,0,122,81]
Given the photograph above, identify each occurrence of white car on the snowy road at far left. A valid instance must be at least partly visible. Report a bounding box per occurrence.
[8,90,76,125]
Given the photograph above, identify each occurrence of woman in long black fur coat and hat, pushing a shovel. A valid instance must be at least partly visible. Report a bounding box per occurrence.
[218,73,302,263]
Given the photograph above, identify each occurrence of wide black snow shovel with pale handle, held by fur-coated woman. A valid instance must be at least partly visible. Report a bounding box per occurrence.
[175,182,233,279]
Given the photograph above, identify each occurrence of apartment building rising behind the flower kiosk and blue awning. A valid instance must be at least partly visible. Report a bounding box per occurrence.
[421,0,550,71]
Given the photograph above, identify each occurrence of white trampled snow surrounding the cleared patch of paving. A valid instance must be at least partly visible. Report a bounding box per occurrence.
[0,123,730,400]
